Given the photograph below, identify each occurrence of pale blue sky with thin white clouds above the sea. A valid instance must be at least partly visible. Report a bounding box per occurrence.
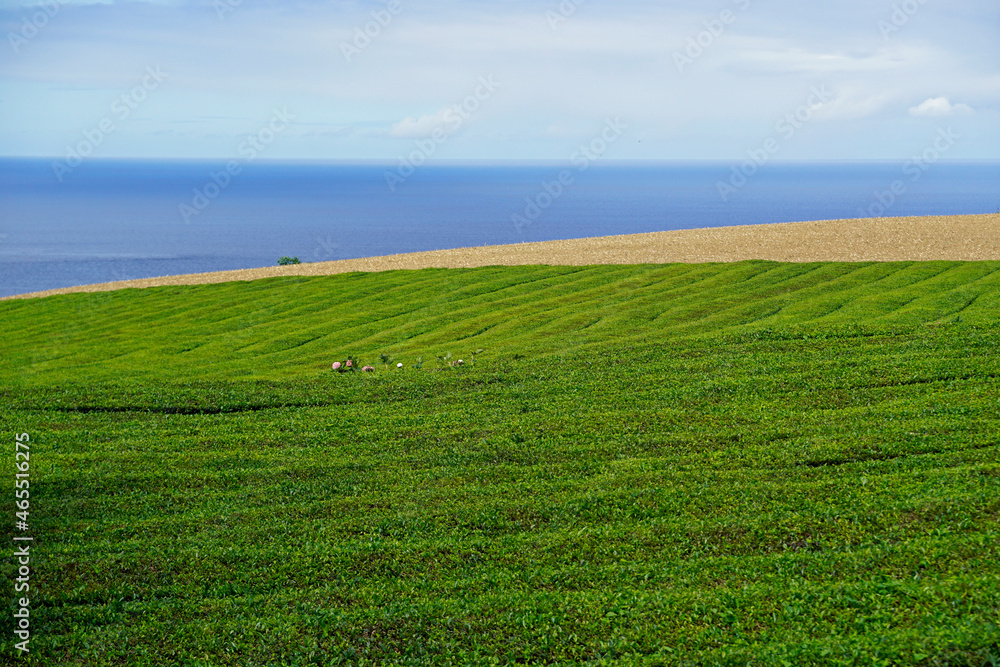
[0,0,1000,162]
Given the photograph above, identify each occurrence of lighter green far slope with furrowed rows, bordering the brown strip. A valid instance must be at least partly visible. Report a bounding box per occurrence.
[0,262,1000,383]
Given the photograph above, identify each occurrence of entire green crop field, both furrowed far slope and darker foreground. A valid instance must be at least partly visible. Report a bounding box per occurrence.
[0,262,1000,665]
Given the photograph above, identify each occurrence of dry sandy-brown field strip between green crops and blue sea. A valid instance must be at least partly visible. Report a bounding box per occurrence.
[6,213,1000,299]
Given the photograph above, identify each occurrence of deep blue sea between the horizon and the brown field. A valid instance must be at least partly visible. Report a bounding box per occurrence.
[0,158,1000,296]
